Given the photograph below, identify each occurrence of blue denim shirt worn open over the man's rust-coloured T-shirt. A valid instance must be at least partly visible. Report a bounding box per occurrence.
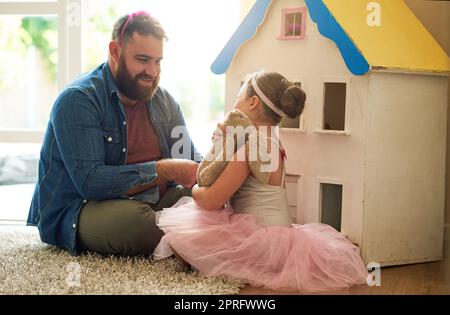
[27,63,201,254]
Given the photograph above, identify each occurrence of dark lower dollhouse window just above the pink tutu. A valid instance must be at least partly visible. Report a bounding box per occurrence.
[320,183,342,231]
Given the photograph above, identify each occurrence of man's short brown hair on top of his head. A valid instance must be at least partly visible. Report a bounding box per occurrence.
[112,14,167,46]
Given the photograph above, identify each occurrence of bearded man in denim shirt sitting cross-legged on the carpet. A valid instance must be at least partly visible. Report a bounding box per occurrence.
[28,12,201,255]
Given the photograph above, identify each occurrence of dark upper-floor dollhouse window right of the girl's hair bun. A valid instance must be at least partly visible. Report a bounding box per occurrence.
[322,82,347,131]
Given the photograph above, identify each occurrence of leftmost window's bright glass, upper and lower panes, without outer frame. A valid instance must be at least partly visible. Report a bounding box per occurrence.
[0,15,58,224]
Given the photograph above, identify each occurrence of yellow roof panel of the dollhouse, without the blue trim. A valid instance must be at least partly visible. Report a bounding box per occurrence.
[323,0,450,73]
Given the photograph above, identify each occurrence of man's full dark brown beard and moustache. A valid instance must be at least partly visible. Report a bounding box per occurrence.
[115,57,159,101]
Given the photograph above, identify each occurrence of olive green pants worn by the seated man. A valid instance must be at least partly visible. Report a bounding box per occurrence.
[77,186,191,256]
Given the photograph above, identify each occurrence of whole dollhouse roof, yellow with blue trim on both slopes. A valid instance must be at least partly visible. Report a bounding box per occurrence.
[211,0,450,75]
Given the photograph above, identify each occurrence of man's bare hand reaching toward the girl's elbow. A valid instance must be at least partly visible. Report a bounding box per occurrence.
[156,159,198,188]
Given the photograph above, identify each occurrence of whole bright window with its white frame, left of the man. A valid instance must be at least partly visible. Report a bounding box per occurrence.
[0,0,81,224]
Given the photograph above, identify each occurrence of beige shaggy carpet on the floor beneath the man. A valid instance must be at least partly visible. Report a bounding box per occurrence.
[0,228,243,295]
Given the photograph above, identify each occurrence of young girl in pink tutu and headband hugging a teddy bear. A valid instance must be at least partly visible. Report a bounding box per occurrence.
[154,72,368,291]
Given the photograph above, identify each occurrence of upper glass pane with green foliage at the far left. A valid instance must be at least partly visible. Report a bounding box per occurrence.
[0,15,58,129]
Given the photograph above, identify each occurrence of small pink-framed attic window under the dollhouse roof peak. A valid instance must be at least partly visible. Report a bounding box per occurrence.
[278,7,306,40]
